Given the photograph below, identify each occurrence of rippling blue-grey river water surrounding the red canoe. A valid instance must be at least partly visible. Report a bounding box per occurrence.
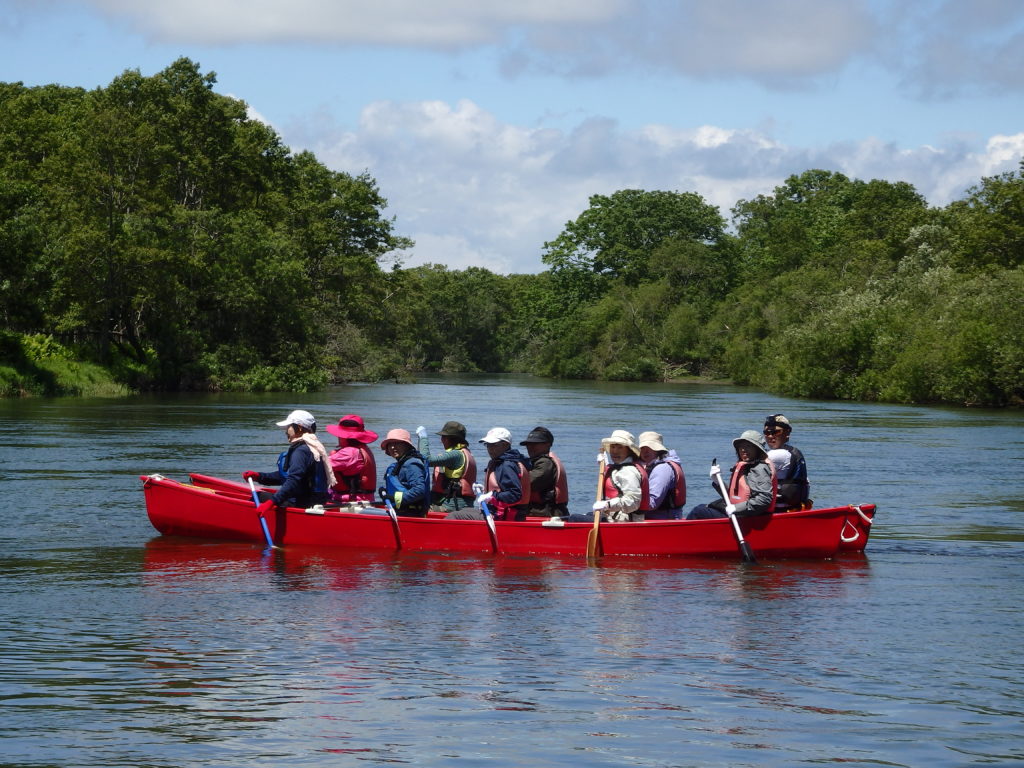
[0,377,1024,768]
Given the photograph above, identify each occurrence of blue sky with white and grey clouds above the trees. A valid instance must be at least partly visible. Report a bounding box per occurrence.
[0,0,1024,273]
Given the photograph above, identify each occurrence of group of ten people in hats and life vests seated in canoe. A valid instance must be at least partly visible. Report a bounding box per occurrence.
[242,411,810,522]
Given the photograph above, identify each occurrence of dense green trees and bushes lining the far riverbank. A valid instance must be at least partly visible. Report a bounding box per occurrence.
[0,58,1024,406]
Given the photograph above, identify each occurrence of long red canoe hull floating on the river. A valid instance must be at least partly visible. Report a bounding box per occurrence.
[140,474,876,559]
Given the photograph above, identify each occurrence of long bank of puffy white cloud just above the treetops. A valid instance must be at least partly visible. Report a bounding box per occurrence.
[293,100,1024,272]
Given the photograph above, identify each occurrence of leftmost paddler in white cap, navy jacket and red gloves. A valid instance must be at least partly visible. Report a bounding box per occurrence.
[242,411,335,516]
